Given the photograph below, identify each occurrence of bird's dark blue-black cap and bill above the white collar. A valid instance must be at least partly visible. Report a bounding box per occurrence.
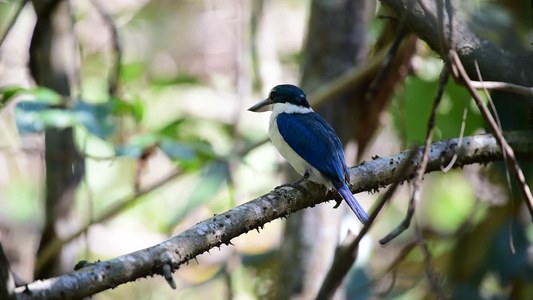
[248,84,311,112]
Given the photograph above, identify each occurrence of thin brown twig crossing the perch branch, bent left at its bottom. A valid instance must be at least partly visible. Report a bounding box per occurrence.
[379,63,450,245]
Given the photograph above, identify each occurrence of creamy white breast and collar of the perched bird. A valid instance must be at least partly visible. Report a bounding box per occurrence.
[268,103,333,188]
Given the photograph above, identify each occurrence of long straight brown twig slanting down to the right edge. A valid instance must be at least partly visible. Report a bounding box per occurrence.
[451,51,533,220]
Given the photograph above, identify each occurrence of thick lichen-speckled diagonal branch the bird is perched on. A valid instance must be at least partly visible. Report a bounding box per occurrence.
[12,131,533,300]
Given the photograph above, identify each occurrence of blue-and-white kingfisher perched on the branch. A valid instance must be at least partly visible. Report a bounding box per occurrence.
[248,84,368,224]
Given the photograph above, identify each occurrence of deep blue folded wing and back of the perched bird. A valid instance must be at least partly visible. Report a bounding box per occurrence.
[277,113,349,189]
